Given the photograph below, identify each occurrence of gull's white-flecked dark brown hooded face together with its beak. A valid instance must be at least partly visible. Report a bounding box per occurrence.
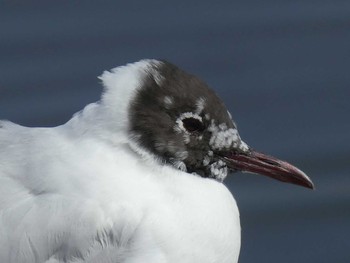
[104,60,313,188]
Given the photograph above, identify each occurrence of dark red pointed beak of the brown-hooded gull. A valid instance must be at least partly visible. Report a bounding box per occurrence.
[224,150,314,189]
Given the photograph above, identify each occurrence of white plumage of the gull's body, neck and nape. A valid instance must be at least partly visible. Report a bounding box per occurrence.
[0,60,240,263]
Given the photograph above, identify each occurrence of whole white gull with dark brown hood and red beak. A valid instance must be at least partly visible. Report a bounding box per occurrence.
[0,59,314,263]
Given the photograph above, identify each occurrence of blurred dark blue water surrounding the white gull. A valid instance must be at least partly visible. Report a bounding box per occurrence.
[0,0,350,263]
